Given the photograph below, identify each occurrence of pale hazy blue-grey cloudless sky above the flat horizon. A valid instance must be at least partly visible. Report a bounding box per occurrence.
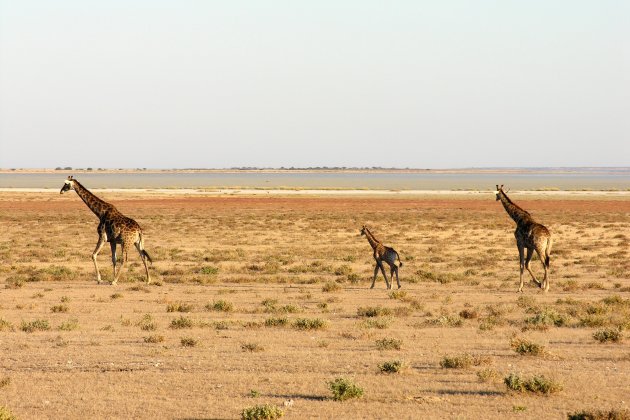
[0,0,630,168]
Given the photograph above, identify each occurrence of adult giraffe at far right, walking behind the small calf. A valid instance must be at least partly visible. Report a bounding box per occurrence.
[495,185,553,292]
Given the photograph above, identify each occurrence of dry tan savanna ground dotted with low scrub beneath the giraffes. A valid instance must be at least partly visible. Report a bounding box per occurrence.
[0,192,630,418]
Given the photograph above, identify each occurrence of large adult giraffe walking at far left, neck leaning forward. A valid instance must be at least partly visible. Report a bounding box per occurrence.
[59,176,153,285]
